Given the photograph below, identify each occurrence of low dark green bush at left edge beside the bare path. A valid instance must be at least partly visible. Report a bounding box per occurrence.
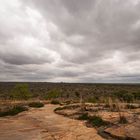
[0,106,28,117]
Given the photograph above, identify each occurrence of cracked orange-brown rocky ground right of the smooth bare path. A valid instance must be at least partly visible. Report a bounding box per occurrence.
[56,104,140,140]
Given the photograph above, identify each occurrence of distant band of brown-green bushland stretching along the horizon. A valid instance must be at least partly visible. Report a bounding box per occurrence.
[0,82,140,102]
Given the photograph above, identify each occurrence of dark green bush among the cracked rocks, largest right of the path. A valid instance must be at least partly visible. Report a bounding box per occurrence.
[89,116,108,127]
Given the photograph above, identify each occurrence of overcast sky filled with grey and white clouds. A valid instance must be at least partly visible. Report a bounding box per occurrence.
[0,0,140,83]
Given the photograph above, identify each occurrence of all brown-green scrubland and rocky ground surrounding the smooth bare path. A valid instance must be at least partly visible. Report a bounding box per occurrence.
[0,83,140,140]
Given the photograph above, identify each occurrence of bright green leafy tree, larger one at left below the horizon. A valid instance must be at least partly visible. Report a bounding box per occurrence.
[11,84,31,100]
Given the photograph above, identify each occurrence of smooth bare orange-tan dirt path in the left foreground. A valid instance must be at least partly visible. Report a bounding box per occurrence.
[0,105,103,140]
